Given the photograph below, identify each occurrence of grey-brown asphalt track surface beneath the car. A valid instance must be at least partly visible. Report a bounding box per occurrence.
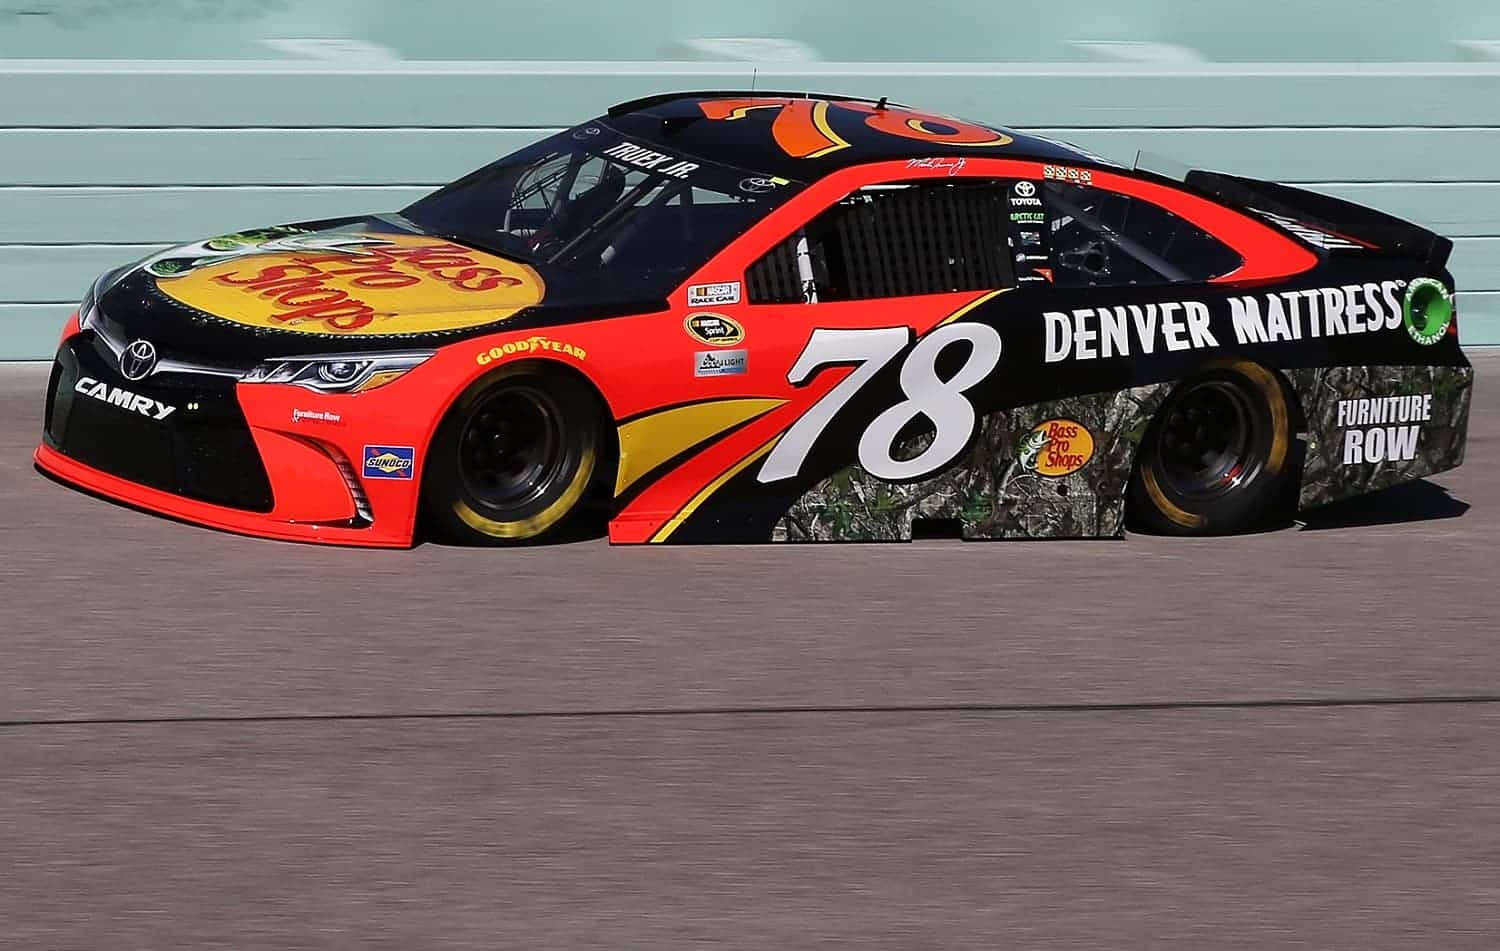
[0,354,1500,951]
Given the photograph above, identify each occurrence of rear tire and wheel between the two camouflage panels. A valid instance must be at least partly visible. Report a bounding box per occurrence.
[1125,360,1295,536]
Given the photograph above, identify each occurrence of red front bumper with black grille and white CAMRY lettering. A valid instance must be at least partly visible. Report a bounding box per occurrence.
[33,320,428,548]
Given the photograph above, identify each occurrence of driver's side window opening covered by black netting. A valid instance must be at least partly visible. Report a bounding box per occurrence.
[746,182,1014,303]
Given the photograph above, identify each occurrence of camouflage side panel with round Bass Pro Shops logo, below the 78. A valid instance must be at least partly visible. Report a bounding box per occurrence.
[773,384,1170,542]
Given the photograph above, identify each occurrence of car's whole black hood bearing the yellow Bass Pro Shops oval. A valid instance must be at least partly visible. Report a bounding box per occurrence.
[99,216,665,366]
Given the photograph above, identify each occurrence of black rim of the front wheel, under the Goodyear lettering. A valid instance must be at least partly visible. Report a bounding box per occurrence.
[459,386,567,513]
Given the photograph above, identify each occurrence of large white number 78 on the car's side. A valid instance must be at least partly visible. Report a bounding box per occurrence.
[756,324,1001,483]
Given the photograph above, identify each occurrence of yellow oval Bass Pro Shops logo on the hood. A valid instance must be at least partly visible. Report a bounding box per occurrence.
[153,234,543,336]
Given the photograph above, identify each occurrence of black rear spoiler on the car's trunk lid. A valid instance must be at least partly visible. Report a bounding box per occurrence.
[1187,171,1454,269]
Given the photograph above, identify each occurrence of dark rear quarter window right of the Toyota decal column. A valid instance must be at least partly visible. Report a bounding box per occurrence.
[1044,182,1244,287]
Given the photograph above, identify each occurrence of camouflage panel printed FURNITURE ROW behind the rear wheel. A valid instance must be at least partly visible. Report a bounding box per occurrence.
[1287,366,1475,509]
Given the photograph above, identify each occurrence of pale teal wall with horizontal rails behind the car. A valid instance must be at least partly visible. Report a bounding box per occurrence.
[0,59,1500,360]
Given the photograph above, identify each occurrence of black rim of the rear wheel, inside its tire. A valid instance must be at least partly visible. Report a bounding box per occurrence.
[1157,380,1260,501]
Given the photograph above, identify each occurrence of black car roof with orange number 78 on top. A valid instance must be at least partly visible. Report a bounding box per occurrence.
[606,90,1103,182]
